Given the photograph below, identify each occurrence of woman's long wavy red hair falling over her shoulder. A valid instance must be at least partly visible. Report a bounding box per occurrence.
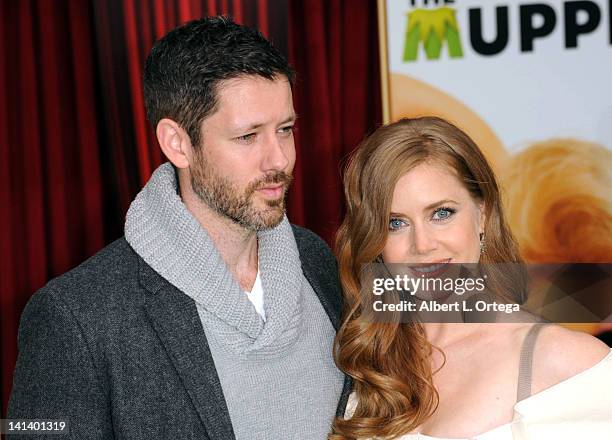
[330,117,521,440]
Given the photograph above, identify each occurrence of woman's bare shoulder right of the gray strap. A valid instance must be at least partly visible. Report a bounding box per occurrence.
[531,325,612,395]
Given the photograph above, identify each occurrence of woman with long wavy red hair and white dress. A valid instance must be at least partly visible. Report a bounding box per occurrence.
[330,117,612,440]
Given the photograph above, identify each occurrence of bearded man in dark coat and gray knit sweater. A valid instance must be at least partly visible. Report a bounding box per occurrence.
[9,18,349,440]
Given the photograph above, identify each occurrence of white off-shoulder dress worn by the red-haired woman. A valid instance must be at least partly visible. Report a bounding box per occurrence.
[346,351,612,440]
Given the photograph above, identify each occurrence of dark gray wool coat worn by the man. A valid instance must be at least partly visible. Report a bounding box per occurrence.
[8,226,350,440]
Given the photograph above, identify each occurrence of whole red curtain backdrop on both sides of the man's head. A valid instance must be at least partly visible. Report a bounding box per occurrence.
[0,0,381,414]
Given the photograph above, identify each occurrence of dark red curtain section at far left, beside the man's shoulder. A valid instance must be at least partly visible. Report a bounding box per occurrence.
[0,0,104,416]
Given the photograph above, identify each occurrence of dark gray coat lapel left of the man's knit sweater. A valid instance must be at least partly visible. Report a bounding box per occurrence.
[140,260,235,440]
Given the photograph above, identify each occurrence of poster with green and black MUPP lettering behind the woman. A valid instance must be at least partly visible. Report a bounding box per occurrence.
[378,0,612,330]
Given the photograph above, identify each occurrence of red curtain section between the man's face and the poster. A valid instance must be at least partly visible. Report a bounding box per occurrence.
[288,0,382,244]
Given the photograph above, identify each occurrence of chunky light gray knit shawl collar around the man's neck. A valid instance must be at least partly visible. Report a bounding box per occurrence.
[125,163,303,354]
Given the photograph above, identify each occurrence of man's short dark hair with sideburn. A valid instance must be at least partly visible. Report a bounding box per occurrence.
[144,17,294,148]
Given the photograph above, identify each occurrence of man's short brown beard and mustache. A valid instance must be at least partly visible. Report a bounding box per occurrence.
[190,151,293,231]
